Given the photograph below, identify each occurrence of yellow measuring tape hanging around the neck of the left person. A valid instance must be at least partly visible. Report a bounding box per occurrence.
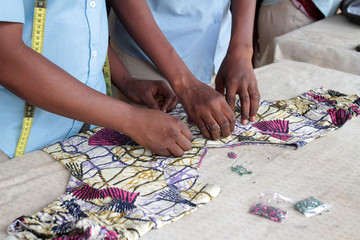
[14,0,112,157]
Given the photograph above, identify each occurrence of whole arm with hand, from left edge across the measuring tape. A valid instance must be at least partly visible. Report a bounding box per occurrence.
[0,22,192,156]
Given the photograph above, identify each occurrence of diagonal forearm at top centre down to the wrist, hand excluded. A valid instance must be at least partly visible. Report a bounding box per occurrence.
[111,0,196,92]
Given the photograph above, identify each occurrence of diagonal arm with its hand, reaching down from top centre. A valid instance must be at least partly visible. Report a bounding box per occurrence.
[111,0,235,140]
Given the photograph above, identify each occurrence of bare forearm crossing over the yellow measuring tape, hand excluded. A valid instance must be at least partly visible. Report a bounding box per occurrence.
[0,24,132,135]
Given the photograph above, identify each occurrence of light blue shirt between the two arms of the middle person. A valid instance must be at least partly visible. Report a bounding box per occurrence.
[111,0,231,83]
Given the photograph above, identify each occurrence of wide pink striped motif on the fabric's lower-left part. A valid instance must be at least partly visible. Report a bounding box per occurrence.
[72,184,139,203]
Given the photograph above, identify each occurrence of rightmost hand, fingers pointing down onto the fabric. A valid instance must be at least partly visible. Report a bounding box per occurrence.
[215,54,260,124]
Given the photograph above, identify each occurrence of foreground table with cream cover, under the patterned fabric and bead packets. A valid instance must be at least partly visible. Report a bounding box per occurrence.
[0,61,360,240]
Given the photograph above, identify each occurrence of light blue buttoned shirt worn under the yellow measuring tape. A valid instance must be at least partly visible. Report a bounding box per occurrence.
[0,0,108,157]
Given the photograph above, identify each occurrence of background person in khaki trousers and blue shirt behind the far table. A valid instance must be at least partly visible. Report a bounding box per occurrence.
[258,0,340,59]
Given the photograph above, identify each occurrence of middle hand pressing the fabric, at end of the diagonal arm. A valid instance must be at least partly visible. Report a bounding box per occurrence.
[177,79,235,140]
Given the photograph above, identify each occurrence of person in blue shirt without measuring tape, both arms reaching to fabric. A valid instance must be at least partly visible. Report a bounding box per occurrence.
[110,0,260,140]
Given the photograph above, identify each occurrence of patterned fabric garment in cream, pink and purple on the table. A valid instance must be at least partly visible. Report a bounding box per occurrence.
[9,88,360,240]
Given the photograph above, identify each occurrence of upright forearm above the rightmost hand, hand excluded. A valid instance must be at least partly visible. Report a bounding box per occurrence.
[228,0,256,59]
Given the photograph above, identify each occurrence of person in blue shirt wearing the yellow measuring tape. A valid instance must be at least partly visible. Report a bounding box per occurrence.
[0,0,192,157]
